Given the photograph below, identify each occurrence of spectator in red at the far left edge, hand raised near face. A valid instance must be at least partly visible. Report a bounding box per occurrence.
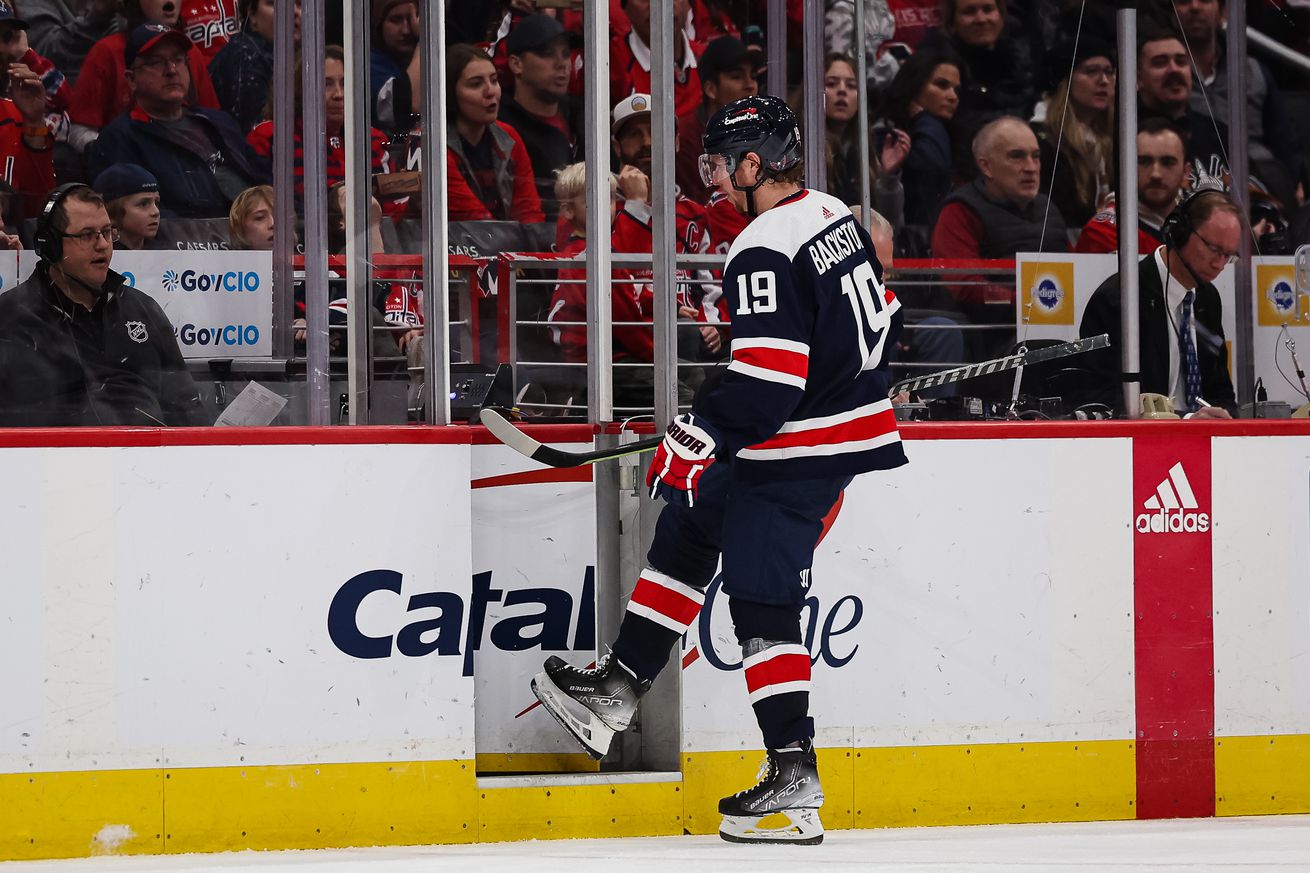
[0,38,55,219]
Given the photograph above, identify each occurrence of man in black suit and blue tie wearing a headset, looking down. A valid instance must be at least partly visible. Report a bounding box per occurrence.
[1078,189,1243,418]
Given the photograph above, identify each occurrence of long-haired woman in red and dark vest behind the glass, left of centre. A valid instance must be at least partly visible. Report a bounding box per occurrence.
[445,45,545,222]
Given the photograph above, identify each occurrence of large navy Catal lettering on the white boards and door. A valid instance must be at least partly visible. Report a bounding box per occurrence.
[328,566,596,676]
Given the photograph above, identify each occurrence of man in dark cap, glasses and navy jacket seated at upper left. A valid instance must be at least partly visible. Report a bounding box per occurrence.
[86,24,271,218]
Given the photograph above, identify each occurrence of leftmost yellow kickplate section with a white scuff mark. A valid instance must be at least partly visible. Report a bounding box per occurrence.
[0,769,164,861]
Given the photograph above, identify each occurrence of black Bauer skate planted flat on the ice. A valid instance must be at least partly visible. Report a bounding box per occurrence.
[719,739,823,845]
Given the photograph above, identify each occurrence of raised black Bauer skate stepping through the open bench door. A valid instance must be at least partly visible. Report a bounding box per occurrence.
[532,654,650,760]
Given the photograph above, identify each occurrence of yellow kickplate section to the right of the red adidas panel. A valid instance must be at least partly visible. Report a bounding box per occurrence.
[1214,734,1310,815]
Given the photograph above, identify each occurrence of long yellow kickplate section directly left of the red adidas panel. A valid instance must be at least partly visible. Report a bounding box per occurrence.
[854,741,1137,827]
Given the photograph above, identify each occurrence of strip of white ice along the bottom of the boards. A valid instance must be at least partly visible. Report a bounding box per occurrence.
[0,815,1310,873]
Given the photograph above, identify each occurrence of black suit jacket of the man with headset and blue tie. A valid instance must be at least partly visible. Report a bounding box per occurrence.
[1078,254,1237,414]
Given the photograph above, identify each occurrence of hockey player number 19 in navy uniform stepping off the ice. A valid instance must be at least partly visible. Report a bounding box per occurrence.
[533,97,905,843]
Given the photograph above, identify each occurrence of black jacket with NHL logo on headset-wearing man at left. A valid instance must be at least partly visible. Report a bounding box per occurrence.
[0,262,212,427]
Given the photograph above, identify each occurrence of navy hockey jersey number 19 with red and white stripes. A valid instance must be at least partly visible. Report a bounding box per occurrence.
[697,190,905,480]
